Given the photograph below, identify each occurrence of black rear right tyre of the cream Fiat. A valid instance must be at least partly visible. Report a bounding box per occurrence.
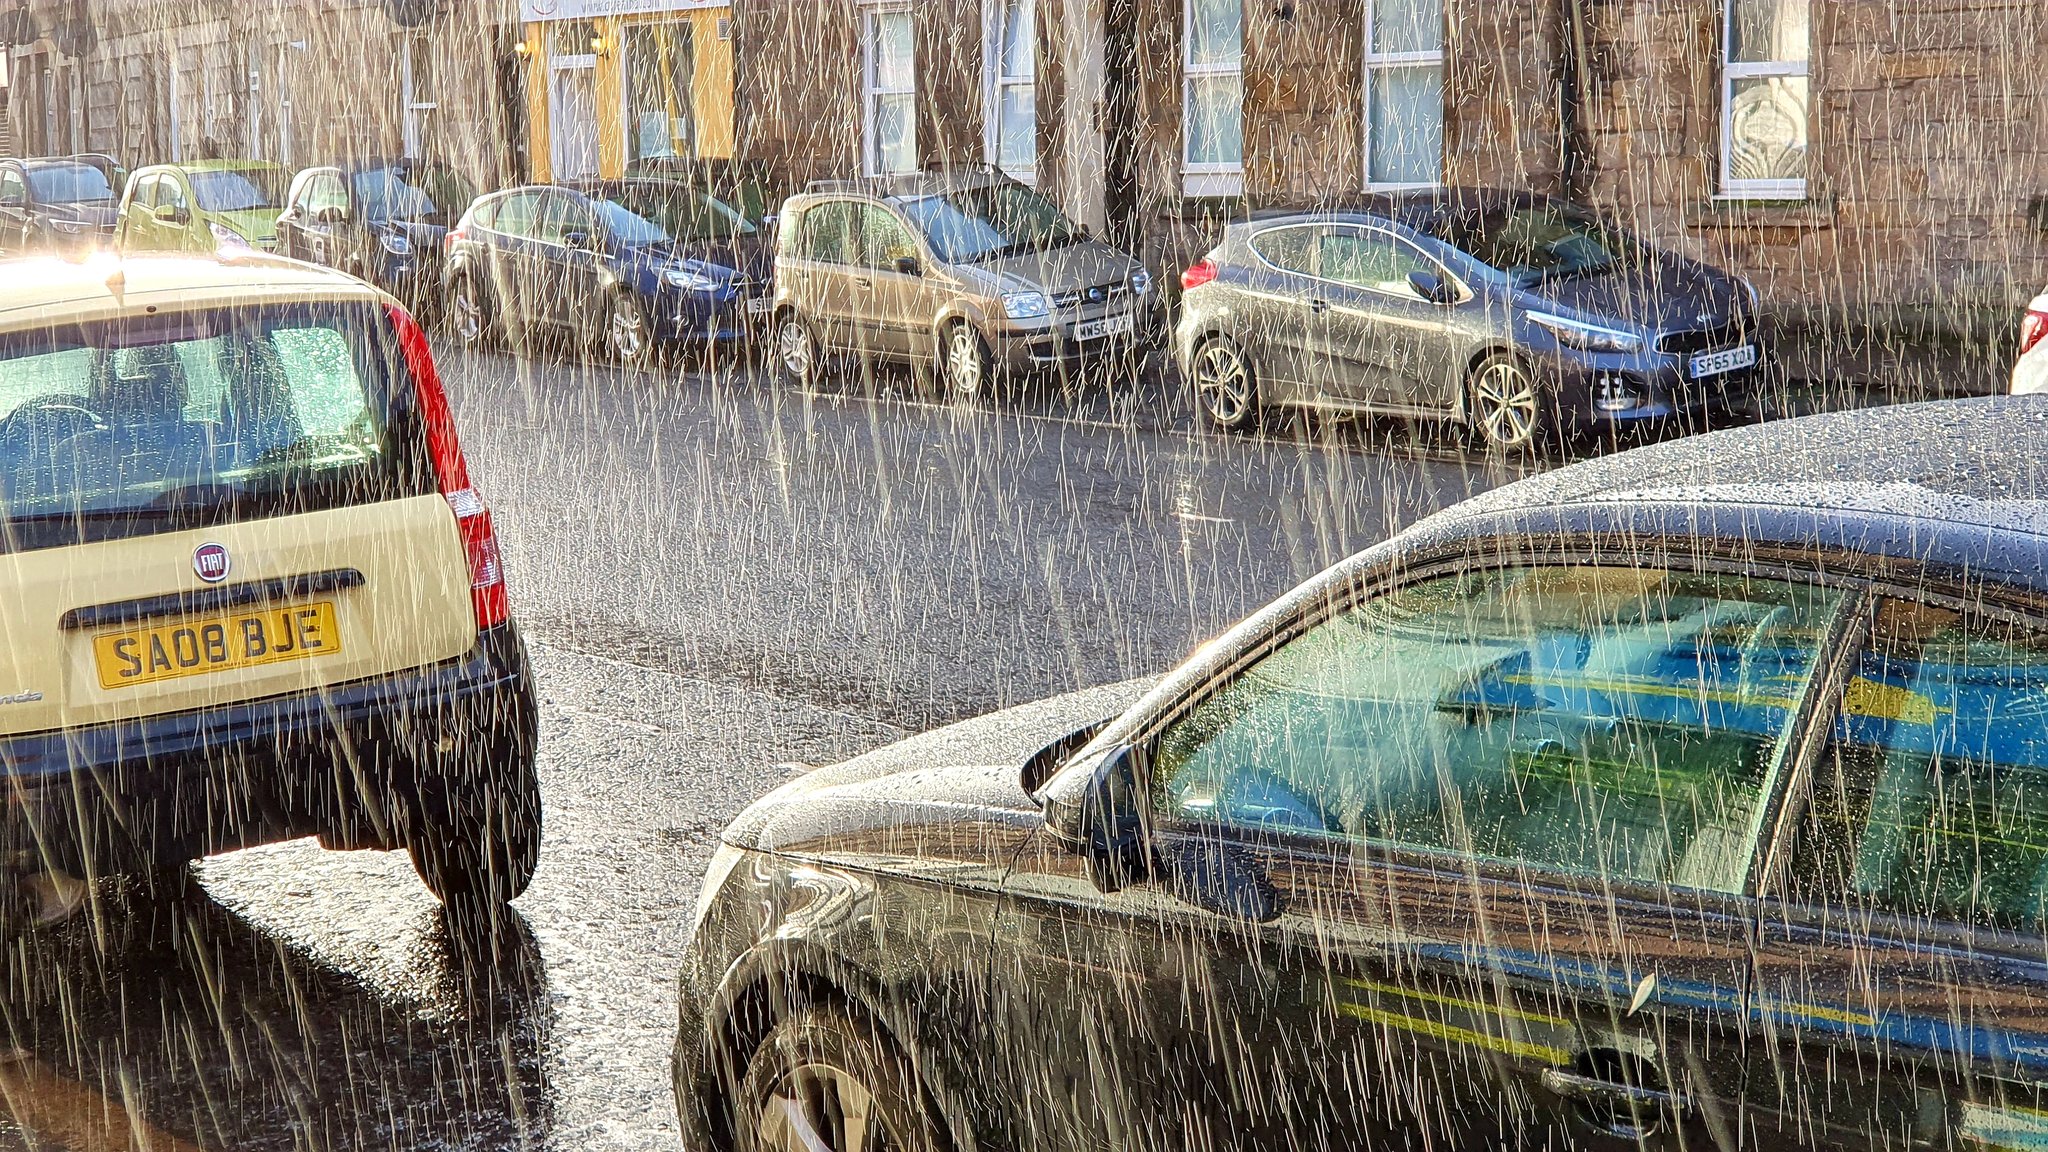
[406,717,541,920]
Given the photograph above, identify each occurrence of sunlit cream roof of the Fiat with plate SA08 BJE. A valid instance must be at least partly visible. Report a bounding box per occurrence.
[0,252,389,332]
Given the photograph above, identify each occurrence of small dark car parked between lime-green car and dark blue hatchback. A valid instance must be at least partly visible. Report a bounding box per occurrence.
[276,158,477,314]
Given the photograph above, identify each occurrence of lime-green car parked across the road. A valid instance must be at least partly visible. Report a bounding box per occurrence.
[115,160,285,252]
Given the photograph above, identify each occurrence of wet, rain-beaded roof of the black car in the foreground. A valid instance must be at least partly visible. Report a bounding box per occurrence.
[1407,396,2048,592]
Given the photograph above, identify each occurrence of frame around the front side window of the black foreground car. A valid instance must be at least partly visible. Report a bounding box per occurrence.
[1128,541,1875,901]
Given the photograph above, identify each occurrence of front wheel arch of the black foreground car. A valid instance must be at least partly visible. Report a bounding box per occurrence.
[692,937,983,1152]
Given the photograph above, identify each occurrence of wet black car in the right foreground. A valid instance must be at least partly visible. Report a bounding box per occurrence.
[674,398,2048,1152]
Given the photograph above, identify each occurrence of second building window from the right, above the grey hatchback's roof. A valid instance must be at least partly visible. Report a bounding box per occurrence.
[1366,0,1444,189]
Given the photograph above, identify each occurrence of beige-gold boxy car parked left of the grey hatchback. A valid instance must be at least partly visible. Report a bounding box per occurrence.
[774,172,1153,400]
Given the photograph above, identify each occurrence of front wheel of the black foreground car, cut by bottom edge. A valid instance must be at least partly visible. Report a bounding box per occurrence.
[733,1004,946,1152]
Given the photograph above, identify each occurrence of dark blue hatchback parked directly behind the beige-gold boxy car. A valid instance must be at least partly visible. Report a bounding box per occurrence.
[444,180,772,363]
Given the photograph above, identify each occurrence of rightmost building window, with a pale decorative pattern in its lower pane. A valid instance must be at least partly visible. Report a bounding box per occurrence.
[1720,0,1810,199]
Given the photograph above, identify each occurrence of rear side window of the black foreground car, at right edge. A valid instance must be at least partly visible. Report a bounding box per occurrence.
[1788,601,2048,933]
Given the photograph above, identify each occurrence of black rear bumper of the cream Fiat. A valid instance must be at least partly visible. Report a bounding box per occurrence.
[0,623,535,875]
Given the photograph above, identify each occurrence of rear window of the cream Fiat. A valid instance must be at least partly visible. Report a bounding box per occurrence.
[0,305,426,551]
